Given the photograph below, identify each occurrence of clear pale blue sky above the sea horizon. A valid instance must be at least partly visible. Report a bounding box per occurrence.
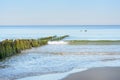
[0,0,120,25]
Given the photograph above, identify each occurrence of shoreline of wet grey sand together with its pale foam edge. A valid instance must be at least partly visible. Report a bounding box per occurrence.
[16,67,120,80]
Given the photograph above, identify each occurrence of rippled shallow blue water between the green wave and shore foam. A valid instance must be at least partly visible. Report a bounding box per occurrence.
[0,44,120,80]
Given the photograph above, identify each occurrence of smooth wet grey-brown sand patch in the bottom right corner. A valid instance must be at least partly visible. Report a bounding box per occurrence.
[62,67,120,80]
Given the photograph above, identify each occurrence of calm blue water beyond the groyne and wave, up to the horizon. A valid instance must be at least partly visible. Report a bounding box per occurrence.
[0,25,120,40]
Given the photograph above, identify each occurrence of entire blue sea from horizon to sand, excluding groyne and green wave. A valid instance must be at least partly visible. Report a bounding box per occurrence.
[0,25,120,80]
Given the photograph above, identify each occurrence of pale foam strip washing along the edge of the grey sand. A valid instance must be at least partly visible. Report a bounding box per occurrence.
[17,69,87,80]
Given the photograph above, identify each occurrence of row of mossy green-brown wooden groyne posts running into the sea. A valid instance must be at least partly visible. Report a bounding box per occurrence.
[0,35,68,59]
